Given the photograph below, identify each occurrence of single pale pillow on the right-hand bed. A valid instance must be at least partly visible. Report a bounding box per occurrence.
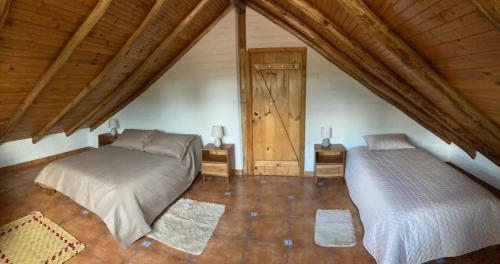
[363,134,415,150]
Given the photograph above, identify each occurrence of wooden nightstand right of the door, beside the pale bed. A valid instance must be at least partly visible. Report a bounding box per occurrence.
[314,144,345,184]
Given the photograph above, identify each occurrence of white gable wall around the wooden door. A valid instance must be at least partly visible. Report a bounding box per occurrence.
[85,9,500,187]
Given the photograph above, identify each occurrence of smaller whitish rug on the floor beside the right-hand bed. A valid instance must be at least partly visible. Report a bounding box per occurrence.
[314,209,356,247]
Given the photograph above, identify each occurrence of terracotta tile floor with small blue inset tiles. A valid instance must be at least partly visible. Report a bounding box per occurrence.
[0,167,500,264]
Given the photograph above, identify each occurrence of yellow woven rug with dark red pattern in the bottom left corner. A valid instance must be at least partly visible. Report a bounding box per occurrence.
[0,212,85,264]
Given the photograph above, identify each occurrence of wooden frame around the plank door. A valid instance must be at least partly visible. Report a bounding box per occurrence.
[240,47,307,176]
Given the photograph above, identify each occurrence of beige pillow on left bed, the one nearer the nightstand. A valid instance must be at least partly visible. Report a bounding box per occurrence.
[144,130,197,161]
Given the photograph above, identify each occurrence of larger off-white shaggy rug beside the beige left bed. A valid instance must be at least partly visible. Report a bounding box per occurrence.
[148,199,226,255]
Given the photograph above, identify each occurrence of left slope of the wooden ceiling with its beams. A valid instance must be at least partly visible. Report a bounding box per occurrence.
[0,0,230,142]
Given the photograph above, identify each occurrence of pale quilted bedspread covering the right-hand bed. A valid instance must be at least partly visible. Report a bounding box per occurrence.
[346,147,500,264]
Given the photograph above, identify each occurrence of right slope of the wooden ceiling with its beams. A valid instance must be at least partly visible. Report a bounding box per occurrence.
[248,0,500,165]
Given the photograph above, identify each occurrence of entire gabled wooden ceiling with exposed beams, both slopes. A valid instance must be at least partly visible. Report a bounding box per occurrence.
[0,0,500,165]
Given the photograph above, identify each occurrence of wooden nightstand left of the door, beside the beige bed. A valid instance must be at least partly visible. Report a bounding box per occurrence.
[201,144,234,183]
